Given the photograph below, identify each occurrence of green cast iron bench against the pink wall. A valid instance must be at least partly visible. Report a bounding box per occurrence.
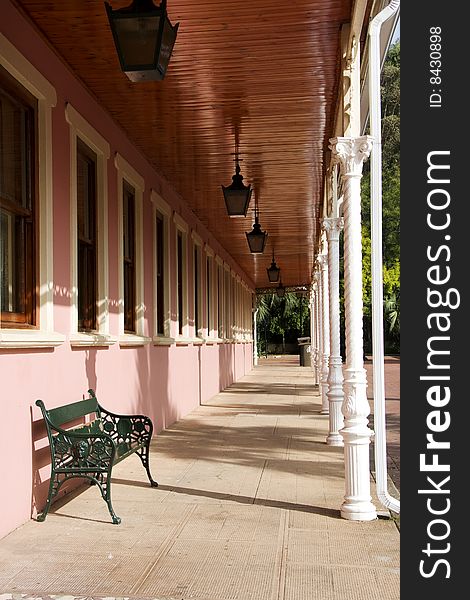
[36,390,158,525]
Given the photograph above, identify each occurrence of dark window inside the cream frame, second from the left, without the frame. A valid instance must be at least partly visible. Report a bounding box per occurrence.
[77,139,97,331]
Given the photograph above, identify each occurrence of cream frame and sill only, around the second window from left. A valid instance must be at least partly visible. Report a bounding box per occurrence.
[65,103,117,346]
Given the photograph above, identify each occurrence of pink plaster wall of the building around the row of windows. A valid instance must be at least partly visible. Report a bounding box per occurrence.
[0,0,253,537]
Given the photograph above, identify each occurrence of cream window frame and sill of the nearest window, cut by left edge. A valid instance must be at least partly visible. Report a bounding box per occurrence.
[0,33,65,348]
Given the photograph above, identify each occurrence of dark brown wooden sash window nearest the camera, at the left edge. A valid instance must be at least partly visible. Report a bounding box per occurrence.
[0,68,38,327]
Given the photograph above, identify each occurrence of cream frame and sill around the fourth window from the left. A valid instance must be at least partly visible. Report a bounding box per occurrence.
[150,190,175,346]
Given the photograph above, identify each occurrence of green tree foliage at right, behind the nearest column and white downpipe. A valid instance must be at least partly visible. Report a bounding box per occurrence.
[362,41,400,352]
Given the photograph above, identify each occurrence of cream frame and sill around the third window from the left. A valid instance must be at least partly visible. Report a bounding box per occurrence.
[114,152,152,347]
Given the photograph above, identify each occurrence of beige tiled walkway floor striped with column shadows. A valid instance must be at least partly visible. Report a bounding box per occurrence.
[0,363,399,600]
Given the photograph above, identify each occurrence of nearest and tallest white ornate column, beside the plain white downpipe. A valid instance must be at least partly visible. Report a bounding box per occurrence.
[330,136,377,521]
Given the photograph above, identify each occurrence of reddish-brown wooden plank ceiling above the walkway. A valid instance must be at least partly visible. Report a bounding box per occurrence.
[18,0,351,287]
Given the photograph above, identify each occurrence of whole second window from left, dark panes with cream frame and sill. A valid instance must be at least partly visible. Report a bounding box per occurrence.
[65,103,112,347]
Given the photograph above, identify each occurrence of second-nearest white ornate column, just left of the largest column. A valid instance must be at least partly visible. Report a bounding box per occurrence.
[323,218,344,446]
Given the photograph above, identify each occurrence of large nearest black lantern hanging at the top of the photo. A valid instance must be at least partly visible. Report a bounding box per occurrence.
[105,0,179,81]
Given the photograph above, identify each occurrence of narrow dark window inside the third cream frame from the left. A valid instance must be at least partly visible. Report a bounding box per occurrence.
[122,181,136,333]
